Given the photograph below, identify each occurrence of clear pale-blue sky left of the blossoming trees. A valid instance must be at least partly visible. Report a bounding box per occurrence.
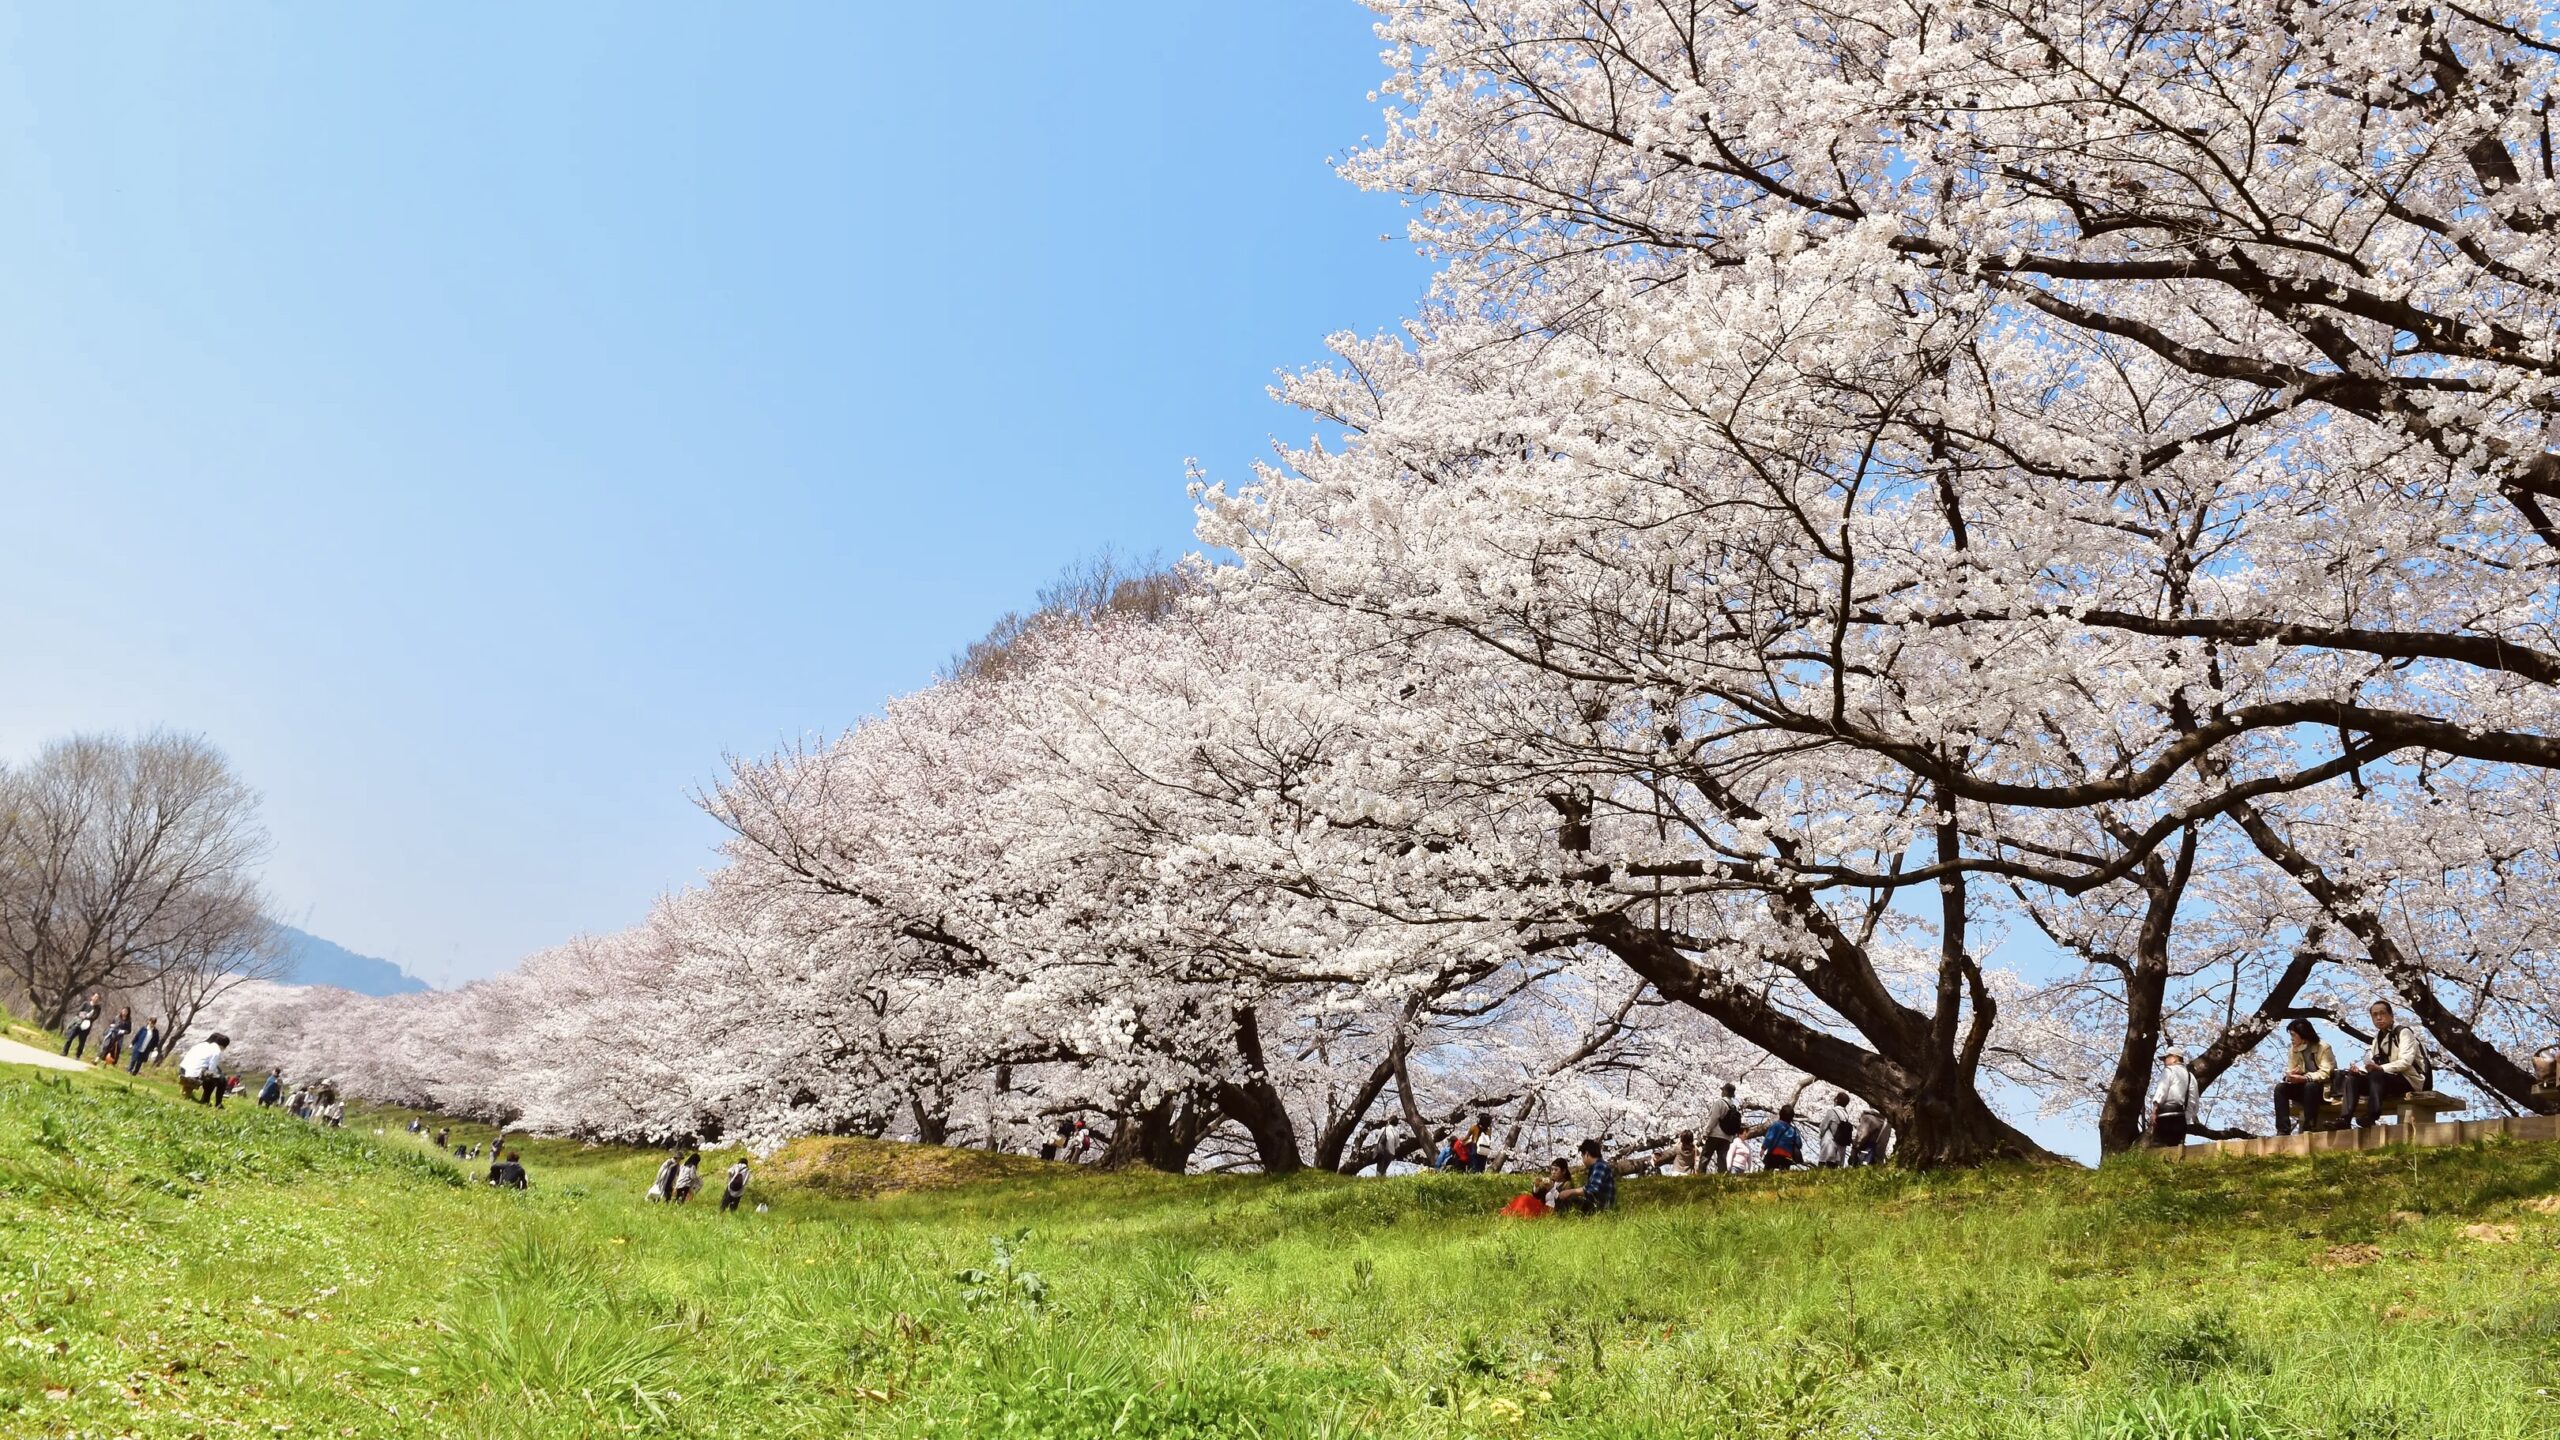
[0,0,1426,984]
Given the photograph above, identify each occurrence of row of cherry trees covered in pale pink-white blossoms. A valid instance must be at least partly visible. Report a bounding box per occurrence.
[215,0,2560,1168]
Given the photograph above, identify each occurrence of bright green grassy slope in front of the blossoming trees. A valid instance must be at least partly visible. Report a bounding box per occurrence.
[0,1068,2560,1440]
